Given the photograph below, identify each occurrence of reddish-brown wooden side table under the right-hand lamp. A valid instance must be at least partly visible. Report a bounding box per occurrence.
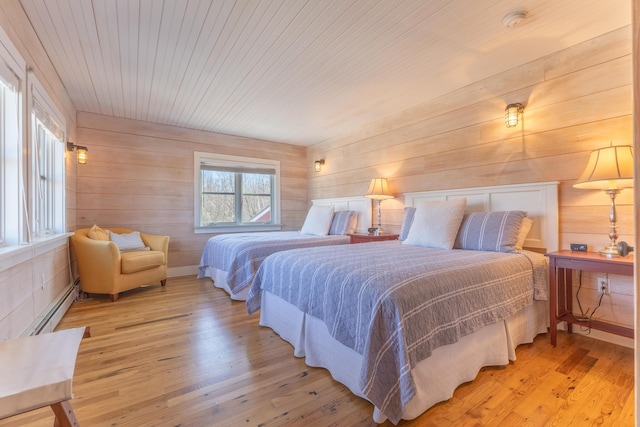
[546,250,633,347]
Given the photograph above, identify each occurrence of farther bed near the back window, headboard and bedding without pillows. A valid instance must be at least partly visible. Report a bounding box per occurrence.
[198,196,371,301]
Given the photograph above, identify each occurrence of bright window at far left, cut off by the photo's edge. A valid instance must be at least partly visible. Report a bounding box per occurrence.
[0,27,25,246]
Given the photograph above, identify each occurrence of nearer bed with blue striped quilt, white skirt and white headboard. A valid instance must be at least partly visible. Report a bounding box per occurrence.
[246,183,557,423]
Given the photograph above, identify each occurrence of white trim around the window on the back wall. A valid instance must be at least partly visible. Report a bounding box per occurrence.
[193,151,282,234]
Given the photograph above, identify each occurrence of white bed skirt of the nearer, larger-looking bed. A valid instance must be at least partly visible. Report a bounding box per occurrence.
[260,291,549,423]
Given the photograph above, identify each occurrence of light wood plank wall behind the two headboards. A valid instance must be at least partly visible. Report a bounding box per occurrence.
[307,26,634,334]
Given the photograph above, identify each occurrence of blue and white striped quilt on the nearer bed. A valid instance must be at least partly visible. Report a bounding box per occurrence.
[247,241,548,423]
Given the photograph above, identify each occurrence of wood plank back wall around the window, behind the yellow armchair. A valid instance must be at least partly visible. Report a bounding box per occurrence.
[77,113,307,269]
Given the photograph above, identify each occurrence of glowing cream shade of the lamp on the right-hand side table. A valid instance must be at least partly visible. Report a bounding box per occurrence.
[573,145,633,190]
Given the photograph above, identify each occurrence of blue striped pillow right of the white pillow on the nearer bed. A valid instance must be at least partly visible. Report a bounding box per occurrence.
[453,211,527,252]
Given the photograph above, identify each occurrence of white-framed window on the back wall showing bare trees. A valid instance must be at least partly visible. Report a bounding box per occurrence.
[194,152,281,233]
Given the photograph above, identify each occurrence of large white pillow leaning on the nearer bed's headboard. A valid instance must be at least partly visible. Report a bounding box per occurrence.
[402,197,467,249]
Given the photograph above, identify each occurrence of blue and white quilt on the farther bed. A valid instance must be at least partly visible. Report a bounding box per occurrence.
[198,231,349,294]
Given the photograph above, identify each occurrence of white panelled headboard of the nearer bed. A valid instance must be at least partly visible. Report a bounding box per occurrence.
[404,182,558,252]
